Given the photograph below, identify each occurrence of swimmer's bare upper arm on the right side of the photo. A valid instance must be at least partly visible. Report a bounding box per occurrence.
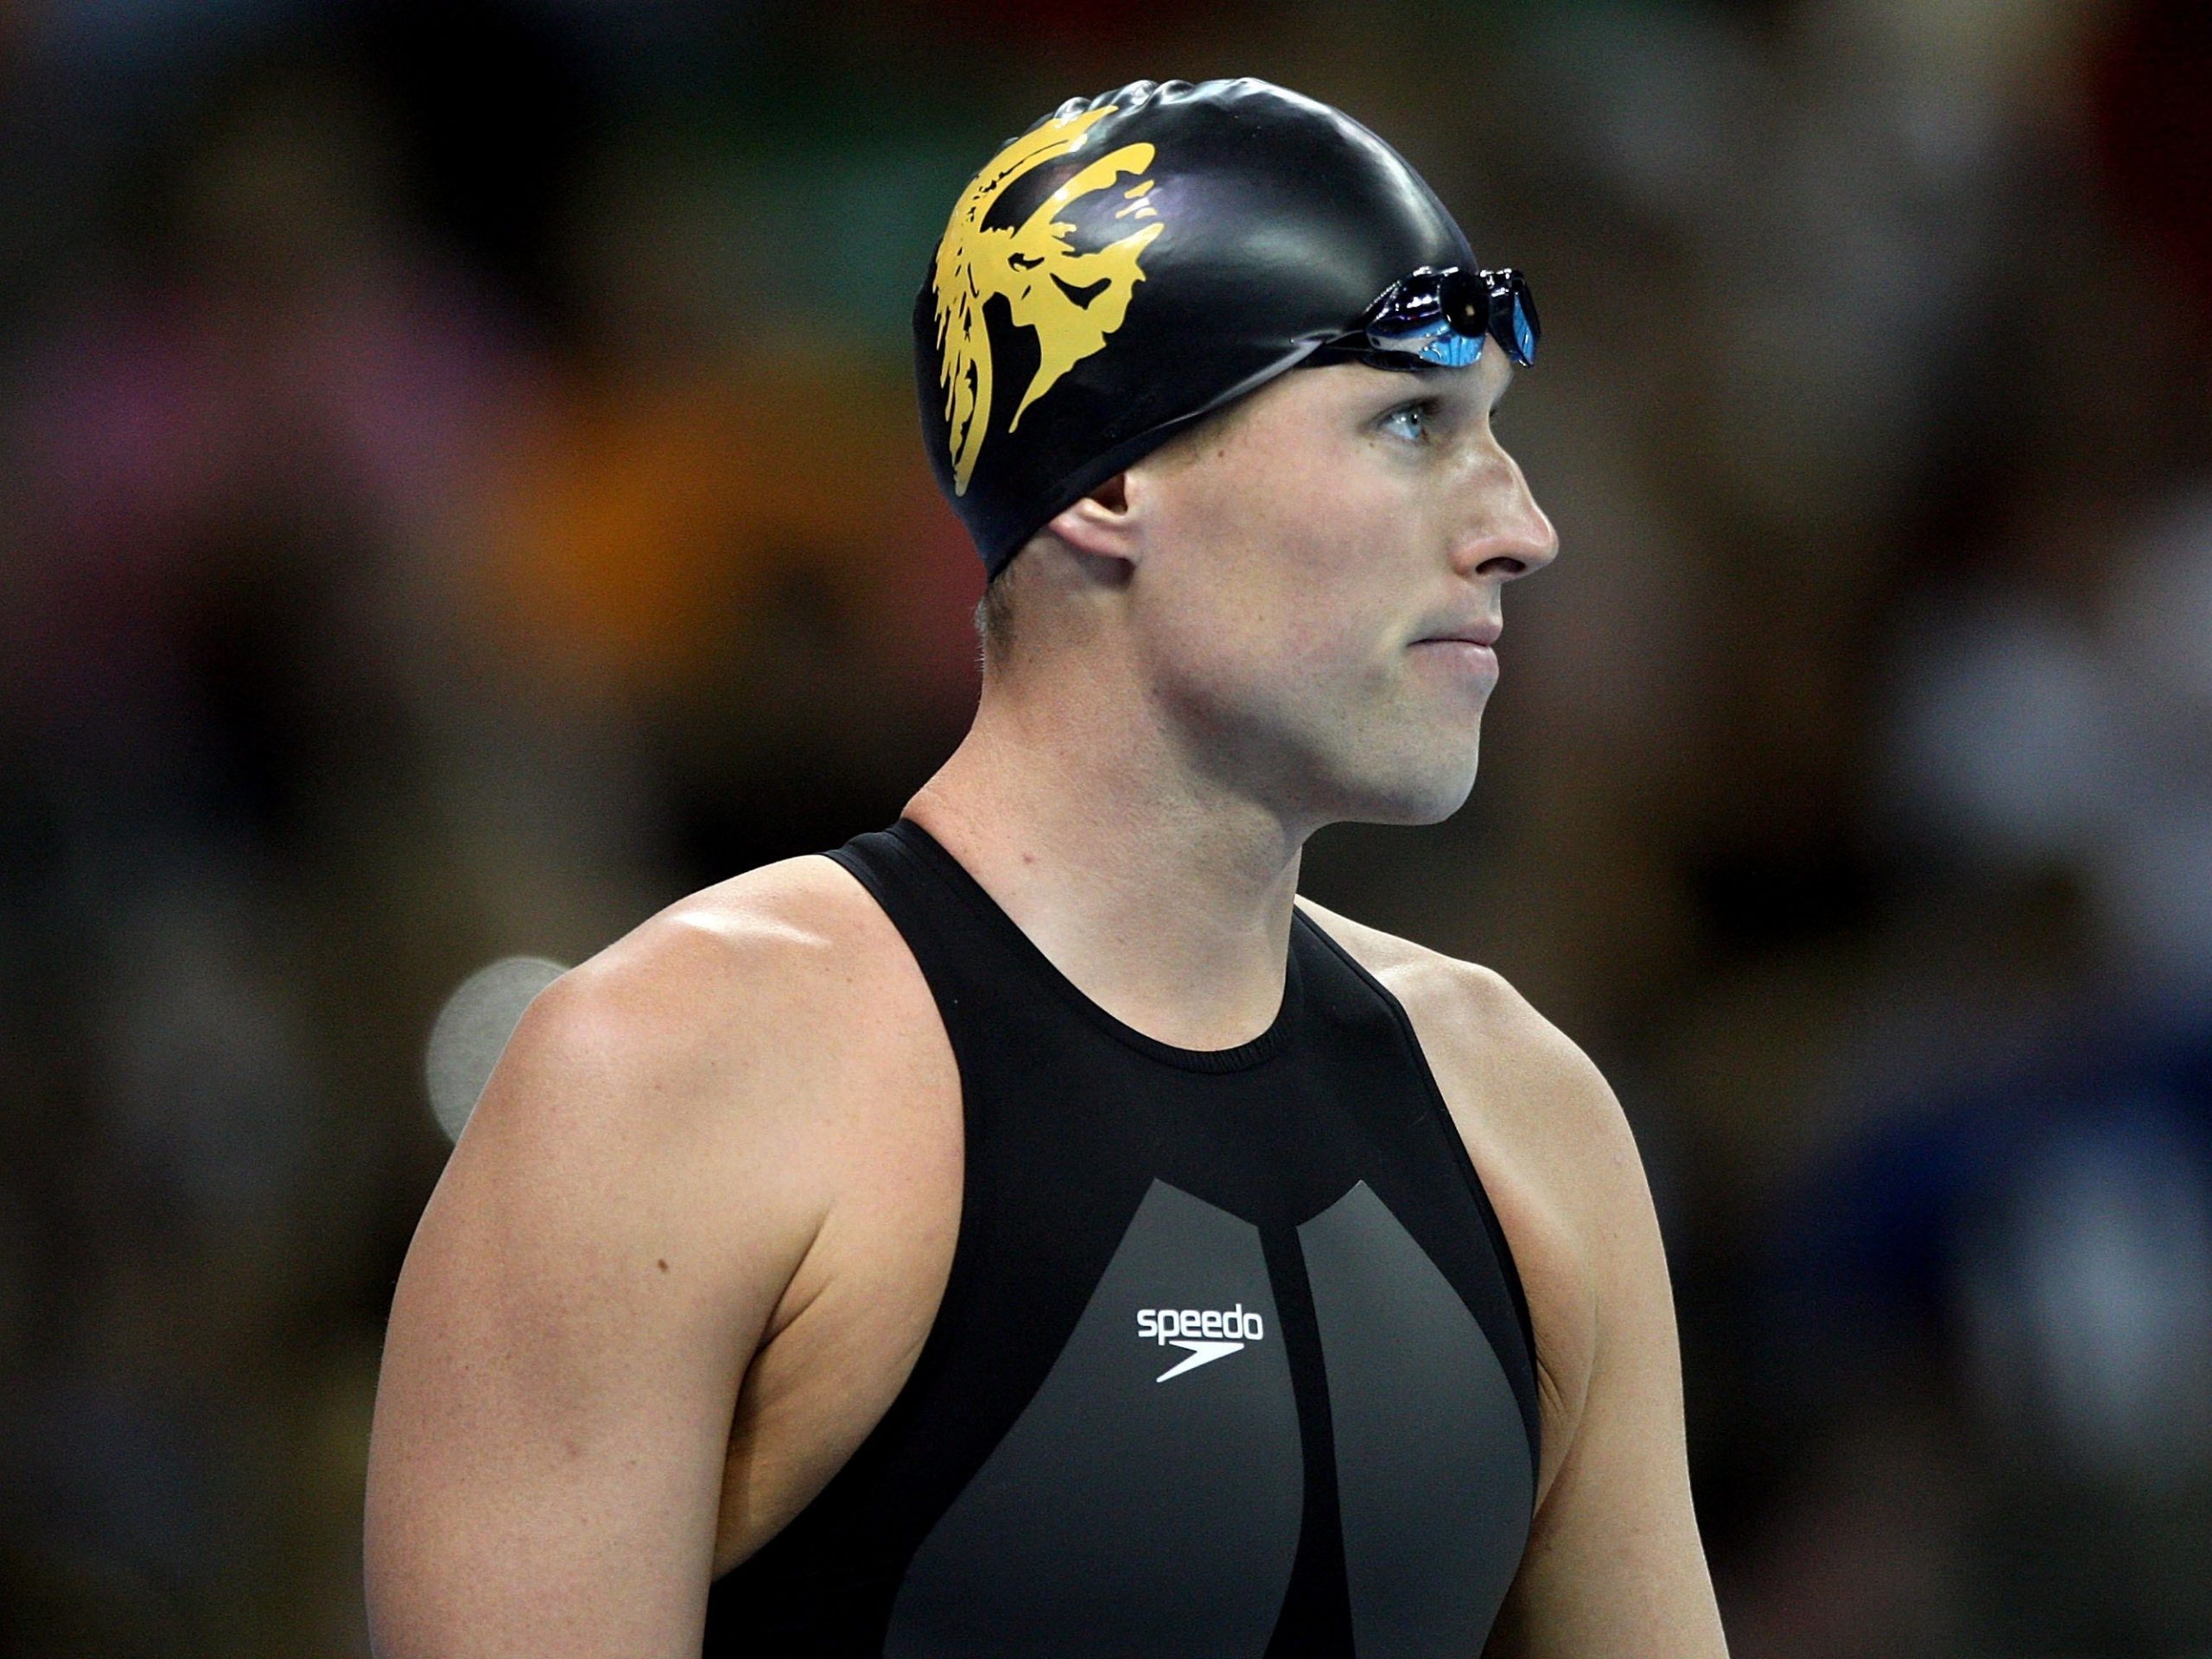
[1486,1128,1726,1659]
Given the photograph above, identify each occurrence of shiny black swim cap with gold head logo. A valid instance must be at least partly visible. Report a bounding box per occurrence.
[913,79,1473,575]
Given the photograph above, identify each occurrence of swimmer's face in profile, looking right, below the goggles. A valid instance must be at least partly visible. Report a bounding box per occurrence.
[1126,343,1557,825]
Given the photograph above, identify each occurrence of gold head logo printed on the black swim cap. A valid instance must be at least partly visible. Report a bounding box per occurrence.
[931,104,1164,495]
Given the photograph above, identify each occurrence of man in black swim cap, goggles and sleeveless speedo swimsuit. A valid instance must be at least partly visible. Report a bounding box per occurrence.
[367,79,1723,1659]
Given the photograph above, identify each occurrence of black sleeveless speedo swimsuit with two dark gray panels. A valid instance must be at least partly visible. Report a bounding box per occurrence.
[706,823,1537,1659]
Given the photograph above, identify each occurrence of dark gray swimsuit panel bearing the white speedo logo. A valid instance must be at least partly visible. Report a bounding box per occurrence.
[885,1181,1305,1659]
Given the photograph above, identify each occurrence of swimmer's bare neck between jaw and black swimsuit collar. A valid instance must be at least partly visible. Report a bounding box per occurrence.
[907,654,1303,1048]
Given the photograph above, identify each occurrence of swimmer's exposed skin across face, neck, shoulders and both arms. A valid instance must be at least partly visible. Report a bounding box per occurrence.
[367,349,1726,1659]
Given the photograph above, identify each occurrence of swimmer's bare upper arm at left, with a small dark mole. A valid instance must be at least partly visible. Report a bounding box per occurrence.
[367,925,821,1659]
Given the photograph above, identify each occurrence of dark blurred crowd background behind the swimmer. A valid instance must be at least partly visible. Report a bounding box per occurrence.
[0,0,2212,1659]
